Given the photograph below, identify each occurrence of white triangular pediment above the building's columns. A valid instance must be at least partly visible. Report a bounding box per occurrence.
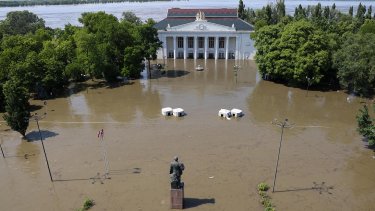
[166,20,236,32]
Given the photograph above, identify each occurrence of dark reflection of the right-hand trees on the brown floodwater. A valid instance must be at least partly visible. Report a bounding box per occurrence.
[248,81,360,127]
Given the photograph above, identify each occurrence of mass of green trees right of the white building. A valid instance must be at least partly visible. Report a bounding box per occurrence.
[250,1,375,96]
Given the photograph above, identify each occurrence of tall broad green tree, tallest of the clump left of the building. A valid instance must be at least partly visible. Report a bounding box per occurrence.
[78,12,131,81]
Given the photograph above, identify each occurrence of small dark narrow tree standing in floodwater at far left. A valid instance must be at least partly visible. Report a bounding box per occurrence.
[3,79,30,137]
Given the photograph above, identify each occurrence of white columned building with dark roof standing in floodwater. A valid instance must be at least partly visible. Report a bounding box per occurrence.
[155,8,255,59]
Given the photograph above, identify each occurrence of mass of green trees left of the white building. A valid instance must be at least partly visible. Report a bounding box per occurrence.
[0,11,161,135]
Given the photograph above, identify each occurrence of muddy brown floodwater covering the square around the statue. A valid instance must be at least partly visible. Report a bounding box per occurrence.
[0,60,375,211]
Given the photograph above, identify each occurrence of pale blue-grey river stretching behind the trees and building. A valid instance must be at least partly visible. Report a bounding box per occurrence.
[0,0,375,28]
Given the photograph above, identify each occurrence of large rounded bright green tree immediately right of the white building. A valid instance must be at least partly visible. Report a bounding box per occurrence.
[254,20,329,85]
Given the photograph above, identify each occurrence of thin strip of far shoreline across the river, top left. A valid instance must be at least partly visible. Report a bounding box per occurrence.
[0,0,181,7]
